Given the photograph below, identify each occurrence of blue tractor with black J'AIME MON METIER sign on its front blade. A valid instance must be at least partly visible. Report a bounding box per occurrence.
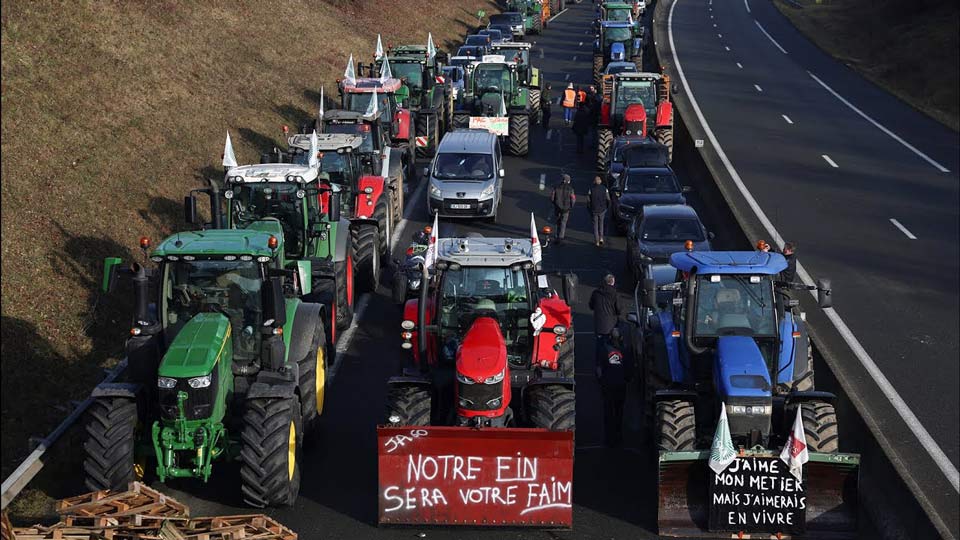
[635,251,859,538]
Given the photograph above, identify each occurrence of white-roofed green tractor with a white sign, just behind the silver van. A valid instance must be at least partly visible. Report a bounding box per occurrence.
[453,56,534,156]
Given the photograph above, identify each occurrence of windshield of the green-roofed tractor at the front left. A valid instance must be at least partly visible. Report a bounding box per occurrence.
[161,258,263,359]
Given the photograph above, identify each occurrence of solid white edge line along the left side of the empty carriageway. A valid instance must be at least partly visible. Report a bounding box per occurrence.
[667,0,960,493]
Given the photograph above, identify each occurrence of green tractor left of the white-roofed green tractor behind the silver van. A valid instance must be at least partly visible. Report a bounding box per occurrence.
[371,37,454,158]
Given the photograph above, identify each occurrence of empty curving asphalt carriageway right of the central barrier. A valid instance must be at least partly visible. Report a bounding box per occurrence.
[657,0,960,530]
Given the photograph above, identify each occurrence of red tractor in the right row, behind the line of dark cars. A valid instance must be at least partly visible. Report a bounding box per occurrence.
[597,73,673,171]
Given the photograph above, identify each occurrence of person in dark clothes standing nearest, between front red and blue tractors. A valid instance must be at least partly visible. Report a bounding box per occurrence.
[596,326,635,447]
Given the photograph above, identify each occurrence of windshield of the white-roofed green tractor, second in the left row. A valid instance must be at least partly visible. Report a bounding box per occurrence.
[230,182,306,255]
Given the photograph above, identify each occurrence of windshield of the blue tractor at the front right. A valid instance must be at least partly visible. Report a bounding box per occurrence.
[695,274,777,337]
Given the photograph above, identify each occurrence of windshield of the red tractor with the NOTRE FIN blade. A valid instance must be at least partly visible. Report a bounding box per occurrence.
[440,266,531,362]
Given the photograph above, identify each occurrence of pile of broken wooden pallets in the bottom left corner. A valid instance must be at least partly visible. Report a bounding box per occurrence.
[3,482,297,540]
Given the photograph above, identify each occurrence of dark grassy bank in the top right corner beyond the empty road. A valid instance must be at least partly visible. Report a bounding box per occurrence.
[774,0,960,131]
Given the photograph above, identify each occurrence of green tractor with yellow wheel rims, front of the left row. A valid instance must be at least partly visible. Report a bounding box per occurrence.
[82,210,336,507]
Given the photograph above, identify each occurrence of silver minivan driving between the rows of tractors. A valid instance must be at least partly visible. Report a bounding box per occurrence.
[424,129,505,220]
